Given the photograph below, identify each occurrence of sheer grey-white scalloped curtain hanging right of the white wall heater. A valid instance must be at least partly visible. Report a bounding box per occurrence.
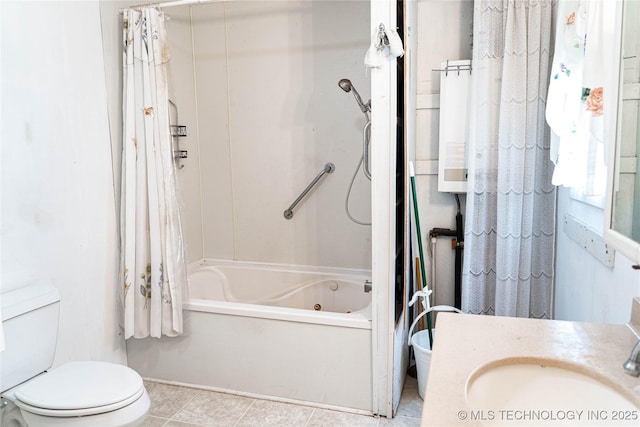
[462,0,555,318]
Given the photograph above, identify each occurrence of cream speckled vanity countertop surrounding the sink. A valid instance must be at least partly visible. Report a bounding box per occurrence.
[422,298,640,427]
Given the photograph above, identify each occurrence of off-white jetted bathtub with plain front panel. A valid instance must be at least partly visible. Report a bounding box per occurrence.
[127,260,372,414]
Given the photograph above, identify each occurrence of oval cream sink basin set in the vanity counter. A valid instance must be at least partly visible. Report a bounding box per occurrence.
[465,358,640,427]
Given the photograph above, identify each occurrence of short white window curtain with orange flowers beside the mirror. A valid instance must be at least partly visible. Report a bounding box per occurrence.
[546,0,615,196]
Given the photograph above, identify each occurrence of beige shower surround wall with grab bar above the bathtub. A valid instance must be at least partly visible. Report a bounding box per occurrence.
[167,1,375,269]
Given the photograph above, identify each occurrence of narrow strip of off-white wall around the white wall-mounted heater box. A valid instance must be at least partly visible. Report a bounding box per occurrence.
[416,0,473,305]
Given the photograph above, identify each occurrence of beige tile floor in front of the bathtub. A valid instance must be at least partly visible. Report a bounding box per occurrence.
[143,376,422,427]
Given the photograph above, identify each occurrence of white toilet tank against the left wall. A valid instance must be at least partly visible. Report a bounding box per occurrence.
[0,285,60,392]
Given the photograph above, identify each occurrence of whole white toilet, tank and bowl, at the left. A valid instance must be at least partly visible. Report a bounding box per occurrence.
[0,285,150,427]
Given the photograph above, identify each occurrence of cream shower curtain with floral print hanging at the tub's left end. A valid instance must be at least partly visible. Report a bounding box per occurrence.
[120,7,187,338]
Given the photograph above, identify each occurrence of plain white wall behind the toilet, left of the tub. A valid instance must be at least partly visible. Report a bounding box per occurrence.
[0,1,125,365]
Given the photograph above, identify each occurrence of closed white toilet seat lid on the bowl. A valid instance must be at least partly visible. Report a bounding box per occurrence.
[15,362,144,417]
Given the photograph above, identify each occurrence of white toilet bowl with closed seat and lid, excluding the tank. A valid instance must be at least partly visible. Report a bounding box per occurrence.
[3,362,150,427]
